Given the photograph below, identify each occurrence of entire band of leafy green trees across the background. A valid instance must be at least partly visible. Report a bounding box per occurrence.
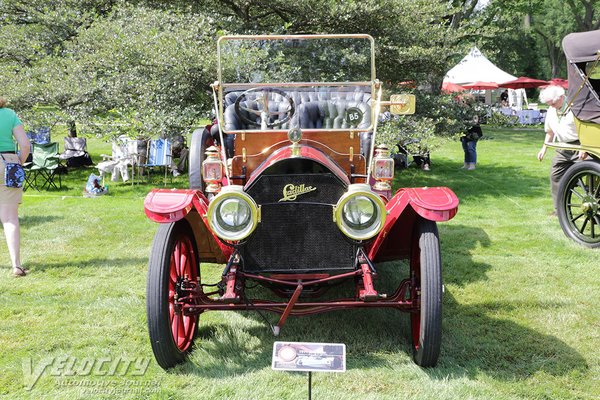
[0,0,600,135]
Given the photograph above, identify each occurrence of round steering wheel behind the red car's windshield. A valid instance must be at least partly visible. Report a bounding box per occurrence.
[235,87,296,129]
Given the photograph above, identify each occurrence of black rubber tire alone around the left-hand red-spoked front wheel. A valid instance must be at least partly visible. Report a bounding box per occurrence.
[146,220,200,369]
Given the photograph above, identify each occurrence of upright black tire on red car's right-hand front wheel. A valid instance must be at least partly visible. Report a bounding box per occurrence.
[410,218,442,367]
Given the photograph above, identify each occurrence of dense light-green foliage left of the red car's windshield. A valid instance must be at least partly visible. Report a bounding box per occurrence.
[0,1,215,135]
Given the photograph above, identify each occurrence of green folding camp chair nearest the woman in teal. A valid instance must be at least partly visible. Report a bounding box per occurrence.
[24,142,64,191]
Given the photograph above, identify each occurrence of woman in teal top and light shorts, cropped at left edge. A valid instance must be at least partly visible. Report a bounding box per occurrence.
[0,97,30,276]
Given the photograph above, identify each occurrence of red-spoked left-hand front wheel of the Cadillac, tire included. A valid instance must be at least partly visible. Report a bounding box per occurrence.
[146,220,199,369]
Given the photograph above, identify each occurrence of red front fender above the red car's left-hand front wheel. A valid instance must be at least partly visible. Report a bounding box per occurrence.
[144,189,233,263]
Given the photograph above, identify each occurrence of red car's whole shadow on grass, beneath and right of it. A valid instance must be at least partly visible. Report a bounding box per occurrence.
[174,225,588,381]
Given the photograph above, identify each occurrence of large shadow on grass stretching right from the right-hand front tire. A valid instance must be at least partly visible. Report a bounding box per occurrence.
[434,292,589,380]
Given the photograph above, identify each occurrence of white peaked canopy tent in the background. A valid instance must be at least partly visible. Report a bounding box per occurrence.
[444,47,527,109]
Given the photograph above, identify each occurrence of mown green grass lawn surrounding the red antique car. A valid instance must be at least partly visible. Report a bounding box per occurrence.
[0,127,600,400]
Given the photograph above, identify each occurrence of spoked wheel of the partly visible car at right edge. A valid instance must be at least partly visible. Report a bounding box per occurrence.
[556,161,600,248]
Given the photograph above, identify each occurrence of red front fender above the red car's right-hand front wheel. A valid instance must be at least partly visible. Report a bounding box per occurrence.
[368,187,458,262]
